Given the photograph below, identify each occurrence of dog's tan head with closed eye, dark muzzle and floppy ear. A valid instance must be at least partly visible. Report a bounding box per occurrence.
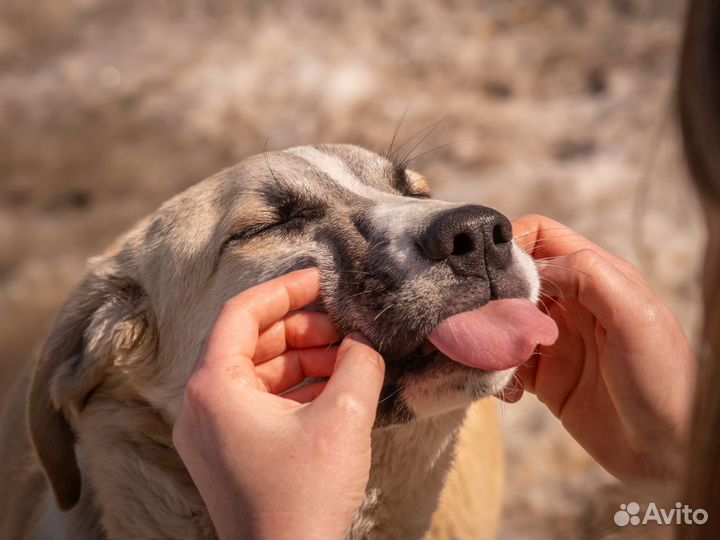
[30,145,539,508]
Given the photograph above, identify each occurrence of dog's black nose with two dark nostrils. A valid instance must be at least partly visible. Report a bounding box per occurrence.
[418,205,512,277]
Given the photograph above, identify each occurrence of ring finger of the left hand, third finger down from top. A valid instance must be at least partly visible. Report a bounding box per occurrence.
[255,347,338,394]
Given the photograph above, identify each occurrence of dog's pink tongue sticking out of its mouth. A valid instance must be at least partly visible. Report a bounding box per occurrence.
[428,298,558,371]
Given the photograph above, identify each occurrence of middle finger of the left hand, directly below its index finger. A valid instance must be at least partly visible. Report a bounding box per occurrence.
[253,312,340,364]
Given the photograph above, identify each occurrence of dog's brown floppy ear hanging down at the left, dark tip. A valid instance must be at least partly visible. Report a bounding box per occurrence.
[28,258,156,510]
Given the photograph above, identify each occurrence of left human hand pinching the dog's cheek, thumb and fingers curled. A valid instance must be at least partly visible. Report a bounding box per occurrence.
[173,269,385,539]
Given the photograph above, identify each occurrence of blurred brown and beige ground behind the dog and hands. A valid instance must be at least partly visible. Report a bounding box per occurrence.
[0,0,704,539]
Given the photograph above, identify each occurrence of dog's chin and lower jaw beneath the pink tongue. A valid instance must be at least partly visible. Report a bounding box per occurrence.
[376,350,515,427]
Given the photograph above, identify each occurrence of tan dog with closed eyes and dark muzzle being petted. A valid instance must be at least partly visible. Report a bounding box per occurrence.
[0,145,540,538]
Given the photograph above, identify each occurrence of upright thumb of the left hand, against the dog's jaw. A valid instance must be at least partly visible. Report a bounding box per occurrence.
[313,333,385,421]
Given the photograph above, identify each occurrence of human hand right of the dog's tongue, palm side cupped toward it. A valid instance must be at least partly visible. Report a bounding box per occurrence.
[513,215,697,481]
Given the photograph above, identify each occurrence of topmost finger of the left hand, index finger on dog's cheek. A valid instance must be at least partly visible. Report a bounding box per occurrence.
[198,268,320,365]
